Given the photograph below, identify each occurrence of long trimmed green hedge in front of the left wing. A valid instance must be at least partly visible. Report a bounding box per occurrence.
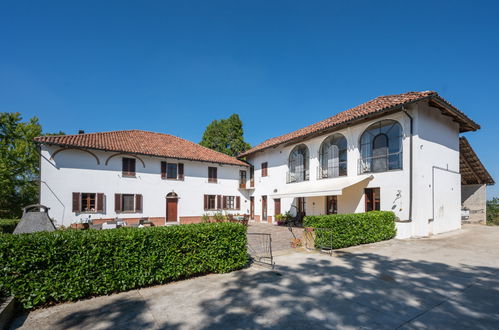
[0,223,248,308]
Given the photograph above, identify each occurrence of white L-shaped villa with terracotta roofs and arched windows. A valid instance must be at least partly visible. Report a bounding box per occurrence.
[36,91,494,238]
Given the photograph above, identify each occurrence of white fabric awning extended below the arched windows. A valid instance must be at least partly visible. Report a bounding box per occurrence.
[270,175,374,198]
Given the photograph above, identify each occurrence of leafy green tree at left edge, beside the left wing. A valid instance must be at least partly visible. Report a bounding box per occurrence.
[0,112,42,218]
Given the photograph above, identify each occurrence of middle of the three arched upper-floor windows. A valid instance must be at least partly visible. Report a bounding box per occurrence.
[319,134,347,179]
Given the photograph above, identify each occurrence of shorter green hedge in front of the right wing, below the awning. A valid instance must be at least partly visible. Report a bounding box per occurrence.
[304,211,397,249]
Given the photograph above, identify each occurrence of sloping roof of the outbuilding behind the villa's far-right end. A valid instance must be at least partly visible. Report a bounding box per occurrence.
[459,137,495,185]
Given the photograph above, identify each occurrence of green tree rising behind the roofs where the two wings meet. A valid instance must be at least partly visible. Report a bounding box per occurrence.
[199,114,251,157]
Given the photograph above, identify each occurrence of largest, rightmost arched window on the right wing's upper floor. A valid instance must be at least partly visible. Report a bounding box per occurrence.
[359,120,402,173]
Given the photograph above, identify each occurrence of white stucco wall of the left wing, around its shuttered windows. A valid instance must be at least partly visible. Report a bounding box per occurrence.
[40,145,249,226]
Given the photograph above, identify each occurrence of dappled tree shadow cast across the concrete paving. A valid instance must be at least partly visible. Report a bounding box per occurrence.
[12,252,499,329]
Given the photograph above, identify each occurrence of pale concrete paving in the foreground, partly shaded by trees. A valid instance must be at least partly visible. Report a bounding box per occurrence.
[8,226,499,329]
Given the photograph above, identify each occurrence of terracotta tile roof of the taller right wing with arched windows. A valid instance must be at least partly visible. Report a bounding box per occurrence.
[239,91,480,157]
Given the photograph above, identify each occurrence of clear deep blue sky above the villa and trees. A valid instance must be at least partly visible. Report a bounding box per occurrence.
[0,0,499,197]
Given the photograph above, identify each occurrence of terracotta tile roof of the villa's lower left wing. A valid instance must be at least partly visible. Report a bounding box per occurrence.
[35,130,248,166]
